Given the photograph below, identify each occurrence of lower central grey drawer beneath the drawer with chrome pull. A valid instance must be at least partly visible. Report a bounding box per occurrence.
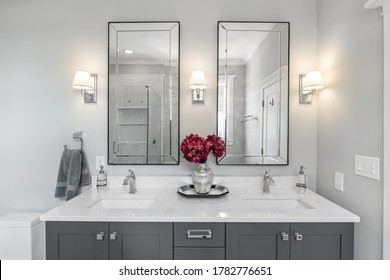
[173,247,225,260]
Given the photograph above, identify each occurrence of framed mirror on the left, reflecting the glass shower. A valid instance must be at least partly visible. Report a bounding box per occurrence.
[108,21,180,165]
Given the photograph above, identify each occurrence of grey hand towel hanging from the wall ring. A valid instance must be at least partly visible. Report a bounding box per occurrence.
[54,149,91,200]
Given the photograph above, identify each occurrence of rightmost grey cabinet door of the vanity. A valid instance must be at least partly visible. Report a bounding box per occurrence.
[290,223,354,260]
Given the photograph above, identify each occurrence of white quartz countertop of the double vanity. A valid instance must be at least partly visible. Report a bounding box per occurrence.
[41,176,360,223]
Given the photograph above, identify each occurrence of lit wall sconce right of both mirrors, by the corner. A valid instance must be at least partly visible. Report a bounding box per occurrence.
[299,71,324,104]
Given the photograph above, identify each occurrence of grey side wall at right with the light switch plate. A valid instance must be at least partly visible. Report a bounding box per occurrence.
[317,0,383,259]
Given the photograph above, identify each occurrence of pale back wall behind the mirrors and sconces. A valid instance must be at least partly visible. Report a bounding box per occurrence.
[0,0,317,214]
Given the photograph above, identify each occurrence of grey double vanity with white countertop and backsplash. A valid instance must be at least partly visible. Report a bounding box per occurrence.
[41,176,359,259]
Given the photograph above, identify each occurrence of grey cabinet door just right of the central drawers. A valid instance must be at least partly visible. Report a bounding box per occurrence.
[226,223,290,260]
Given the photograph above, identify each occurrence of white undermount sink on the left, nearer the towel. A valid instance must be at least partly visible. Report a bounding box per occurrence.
[87,196,156,210]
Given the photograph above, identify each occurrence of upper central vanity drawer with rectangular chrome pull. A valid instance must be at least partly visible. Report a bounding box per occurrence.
[174,223,225,247]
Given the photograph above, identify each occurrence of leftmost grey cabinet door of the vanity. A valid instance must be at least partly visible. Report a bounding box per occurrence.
[46,222,108,260]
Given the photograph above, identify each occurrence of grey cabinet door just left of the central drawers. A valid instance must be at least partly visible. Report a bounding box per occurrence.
[109,223,173,260]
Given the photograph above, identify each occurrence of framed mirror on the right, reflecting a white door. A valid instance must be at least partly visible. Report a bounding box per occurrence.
[217,21,290,165]
